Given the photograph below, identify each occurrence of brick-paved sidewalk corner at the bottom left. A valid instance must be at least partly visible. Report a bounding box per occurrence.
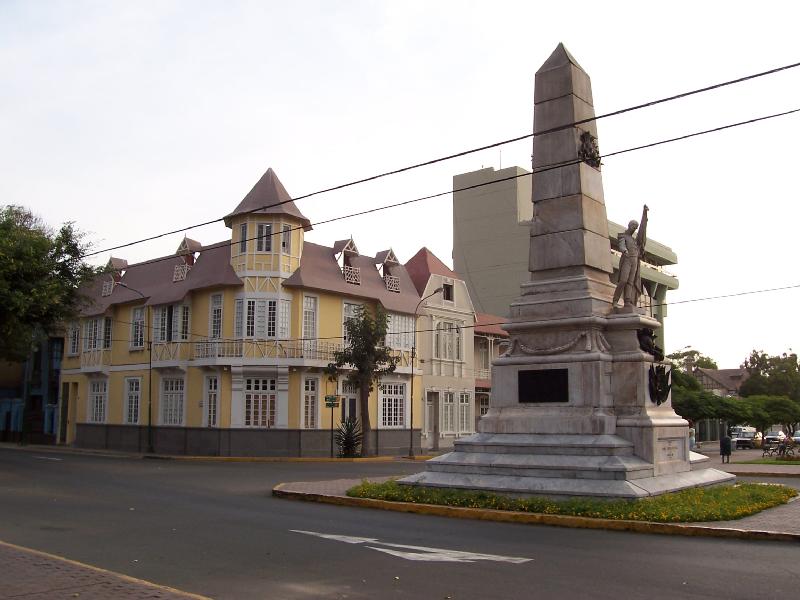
[0,542,208,600]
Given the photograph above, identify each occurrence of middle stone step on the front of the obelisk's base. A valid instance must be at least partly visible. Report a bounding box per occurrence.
[425,452,653,479]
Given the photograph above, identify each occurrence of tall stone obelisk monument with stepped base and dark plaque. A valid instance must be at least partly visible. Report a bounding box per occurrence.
[401,44,733,499]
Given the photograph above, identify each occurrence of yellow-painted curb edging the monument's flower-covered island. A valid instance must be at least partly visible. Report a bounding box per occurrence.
[272,483,800,542]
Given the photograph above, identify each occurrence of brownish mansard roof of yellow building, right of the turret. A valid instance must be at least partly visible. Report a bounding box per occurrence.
[283,242,420,313]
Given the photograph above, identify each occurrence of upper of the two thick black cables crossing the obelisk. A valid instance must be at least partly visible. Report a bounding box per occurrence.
[80,62,800,258]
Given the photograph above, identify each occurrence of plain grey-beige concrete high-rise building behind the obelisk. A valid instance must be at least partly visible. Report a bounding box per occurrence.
[453,167,678,348]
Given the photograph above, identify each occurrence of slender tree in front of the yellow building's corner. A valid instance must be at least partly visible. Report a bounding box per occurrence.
[326,304,398,456]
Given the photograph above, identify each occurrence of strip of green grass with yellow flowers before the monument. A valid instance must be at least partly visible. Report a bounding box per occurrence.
[347,481,797,523]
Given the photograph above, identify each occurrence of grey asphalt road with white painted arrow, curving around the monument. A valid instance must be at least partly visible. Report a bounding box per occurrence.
[0,449,800,600]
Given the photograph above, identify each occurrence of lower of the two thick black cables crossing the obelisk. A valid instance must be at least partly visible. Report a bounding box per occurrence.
[85,108,800,267]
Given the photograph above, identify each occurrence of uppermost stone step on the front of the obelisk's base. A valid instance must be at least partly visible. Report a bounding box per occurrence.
[453,433,633,456]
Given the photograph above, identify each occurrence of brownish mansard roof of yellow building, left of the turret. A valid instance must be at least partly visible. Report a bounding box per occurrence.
[81,240,242,317]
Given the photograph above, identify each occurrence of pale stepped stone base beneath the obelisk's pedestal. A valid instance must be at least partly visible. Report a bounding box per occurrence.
[399,433,736,500]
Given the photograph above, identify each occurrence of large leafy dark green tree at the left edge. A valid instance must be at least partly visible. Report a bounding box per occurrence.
[0,206,97,361]
